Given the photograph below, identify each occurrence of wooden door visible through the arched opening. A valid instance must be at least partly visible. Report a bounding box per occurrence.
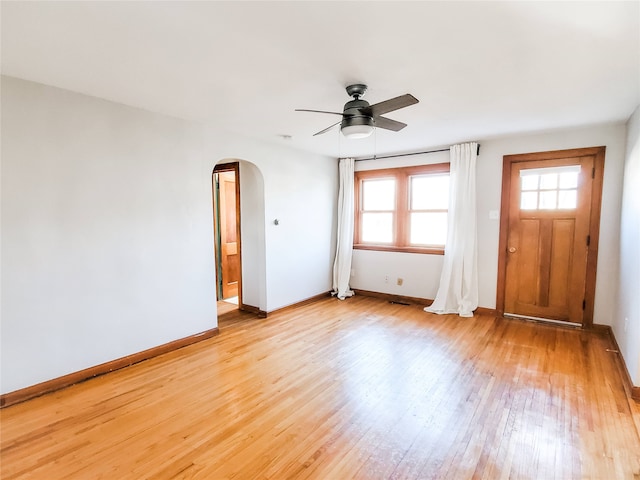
[213,166,241,300]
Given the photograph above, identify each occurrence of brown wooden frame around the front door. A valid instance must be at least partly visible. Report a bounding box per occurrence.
[496,147,606,328]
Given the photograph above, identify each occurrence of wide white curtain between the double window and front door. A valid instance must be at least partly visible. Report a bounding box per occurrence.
[425,143,478,317]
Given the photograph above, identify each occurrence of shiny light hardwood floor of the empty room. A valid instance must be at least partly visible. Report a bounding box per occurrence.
[0,296,640,480]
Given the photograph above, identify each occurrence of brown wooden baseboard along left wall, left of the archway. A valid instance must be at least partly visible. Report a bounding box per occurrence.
[0,327,219,408]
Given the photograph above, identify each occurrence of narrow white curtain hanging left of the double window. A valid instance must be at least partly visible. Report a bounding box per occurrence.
[332,158,355,300]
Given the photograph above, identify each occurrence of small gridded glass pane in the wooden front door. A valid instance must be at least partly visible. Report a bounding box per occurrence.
[520,165,580,210]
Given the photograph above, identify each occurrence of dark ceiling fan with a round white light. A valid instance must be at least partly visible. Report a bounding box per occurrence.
[296,83,418,138]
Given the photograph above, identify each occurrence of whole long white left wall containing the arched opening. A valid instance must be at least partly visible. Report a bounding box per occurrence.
[0,77,338,393]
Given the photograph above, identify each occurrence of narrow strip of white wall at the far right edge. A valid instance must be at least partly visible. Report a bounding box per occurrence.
[612,106,640,386]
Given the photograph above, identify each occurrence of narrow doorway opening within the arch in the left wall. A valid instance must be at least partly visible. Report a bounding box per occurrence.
[212,162,242,316]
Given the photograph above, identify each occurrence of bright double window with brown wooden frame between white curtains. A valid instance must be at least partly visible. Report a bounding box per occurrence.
[354,163,449,254]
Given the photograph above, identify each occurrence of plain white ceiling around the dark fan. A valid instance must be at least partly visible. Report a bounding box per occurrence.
[1,1,640,156]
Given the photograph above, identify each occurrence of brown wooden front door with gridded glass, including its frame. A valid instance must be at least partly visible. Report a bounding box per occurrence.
[498,148,604,324]
